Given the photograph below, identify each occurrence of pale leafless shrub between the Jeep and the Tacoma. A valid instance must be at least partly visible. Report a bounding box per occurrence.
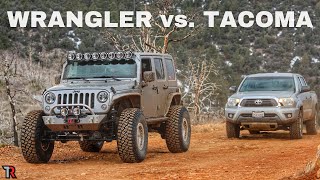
[182,60,218,123]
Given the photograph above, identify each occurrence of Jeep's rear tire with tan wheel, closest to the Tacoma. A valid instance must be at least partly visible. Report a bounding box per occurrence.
[165,106,191,153]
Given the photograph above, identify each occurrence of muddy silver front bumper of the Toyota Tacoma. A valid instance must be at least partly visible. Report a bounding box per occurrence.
[225,107,300,125]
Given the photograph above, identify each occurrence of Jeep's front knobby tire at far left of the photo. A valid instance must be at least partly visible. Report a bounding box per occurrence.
[21,110,54,163]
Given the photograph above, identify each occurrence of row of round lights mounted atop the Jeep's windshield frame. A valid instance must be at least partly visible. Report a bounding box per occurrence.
[68,51,133,61]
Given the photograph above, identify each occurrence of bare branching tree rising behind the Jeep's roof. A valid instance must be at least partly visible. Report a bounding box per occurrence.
[105,0,203,53]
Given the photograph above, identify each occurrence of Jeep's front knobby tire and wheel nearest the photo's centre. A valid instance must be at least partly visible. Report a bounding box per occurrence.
[117,108,148,163]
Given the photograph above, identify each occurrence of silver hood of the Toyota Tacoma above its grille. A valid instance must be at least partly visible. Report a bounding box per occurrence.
[231,91,294,99]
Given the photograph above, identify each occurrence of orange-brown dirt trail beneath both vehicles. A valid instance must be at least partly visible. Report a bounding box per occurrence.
[0,124,320,180]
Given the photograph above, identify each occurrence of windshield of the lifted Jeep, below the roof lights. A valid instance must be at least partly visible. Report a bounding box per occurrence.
[63,59,137,80]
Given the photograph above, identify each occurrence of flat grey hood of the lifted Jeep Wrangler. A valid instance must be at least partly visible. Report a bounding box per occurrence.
[47,80,136,91]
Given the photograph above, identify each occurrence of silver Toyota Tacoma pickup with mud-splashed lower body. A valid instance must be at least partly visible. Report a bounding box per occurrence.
[225,73,318,139]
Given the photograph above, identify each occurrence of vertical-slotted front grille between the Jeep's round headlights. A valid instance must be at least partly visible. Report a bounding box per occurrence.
[58,93,95,108]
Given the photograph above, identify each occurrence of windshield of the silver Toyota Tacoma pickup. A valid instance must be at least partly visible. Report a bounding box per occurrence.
[239,77,295,92]
